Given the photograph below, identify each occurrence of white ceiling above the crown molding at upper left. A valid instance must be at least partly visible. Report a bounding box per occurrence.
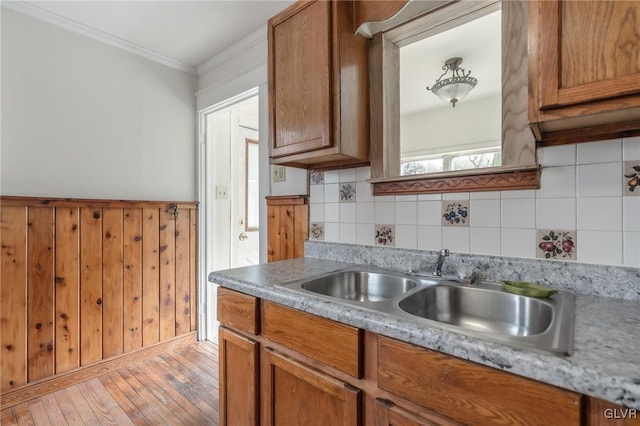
[10,0,293,70]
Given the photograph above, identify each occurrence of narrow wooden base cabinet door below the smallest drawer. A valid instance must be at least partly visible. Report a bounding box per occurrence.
[218,327,260,426]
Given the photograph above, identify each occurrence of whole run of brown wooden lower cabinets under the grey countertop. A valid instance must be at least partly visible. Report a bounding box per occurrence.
[218,288,639,426]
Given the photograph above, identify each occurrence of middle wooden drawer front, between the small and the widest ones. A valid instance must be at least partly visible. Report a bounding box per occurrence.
[262,300,362,378]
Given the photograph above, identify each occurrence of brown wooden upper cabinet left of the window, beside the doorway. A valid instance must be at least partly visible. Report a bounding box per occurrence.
[268,0,369,169]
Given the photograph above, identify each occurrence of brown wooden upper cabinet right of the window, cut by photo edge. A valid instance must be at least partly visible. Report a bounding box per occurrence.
[529,0,640,145]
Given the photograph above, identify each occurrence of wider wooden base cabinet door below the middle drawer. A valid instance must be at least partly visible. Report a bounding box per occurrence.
[262,348,361,426]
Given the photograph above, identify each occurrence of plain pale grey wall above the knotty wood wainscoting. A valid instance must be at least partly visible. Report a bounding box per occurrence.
[1,8,197,201]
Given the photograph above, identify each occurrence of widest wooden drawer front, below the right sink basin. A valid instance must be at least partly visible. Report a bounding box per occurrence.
[378,336,581,425]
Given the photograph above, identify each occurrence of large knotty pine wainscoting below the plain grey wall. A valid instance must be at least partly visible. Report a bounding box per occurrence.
[0,197,197,392]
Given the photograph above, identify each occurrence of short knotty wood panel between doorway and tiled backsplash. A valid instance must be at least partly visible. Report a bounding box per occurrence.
[267,195,309,262]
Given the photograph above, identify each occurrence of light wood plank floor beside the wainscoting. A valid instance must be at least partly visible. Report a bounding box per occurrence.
[0,342,218,426]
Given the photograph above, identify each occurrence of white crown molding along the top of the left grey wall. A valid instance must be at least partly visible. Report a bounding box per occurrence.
[1,1,197,75]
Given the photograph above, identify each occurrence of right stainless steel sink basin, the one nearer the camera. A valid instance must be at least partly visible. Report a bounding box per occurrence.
[398,285,553,336]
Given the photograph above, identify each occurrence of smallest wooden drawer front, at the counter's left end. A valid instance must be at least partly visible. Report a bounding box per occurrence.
[218,287,260,335]
